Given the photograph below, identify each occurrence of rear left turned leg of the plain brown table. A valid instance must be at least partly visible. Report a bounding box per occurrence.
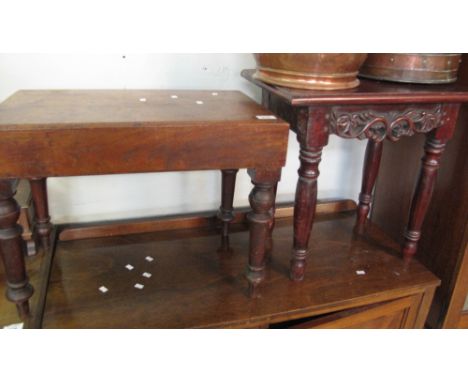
[29,178,52,250]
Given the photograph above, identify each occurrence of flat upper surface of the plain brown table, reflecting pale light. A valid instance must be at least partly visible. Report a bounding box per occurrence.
[0,90,282,131]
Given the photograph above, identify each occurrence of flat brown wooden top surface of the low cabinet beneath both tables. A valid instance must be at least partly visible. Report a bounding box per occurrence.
[0,206,437,328]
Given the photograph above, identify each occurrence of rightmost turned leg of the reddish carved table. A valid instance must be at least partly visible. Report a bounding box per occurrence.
[402,135,446,260]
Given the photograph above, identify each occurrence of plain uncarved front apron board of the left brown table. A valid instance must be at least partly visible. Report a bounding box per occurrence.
[0,123,288,178]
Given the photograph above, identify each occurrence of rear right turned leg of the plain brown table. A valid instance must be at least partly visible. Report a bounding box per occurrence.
[218,169,239,251]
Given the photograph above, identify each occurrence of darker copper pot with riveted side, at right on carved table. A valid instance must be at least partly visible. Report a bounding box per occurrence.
[359,53,461,84]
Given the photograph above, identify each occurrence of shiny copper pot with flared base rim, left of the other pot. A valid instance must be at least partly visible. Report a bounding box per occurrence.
[254,53,367,90]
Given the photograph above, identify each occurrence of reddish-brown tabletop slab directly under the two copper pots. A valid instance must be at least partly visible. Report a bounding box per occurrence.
[242,69,468,106]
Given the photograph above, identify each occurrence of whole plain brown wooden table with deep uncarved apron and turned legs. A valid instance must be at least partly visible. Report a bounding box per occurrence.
[0,90,288,317]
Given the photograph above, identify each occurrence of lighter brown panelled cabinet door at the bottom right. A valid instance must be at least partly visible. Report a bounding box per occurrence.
[289,295,421,329]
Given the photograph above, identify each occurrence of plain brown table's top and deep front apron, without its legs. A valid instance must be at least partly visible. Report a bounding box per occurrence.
[0,90,289,178]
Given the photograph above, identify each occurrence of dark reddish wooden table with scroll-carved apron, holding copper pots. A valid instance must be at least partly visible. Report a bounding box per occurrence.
[242,70,468,280]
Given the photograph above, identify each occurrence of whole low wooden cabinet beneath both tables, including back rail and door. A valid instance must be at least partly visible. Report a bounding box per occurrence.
[0,200,439,328]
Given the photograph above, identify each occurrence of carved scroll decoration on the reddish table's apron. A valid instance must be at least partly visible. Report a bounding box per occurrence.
[329,105,444,142]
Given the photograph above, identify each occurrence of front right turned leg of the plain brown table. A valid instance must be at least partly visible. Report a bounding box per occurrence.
[247,169,281,296]
